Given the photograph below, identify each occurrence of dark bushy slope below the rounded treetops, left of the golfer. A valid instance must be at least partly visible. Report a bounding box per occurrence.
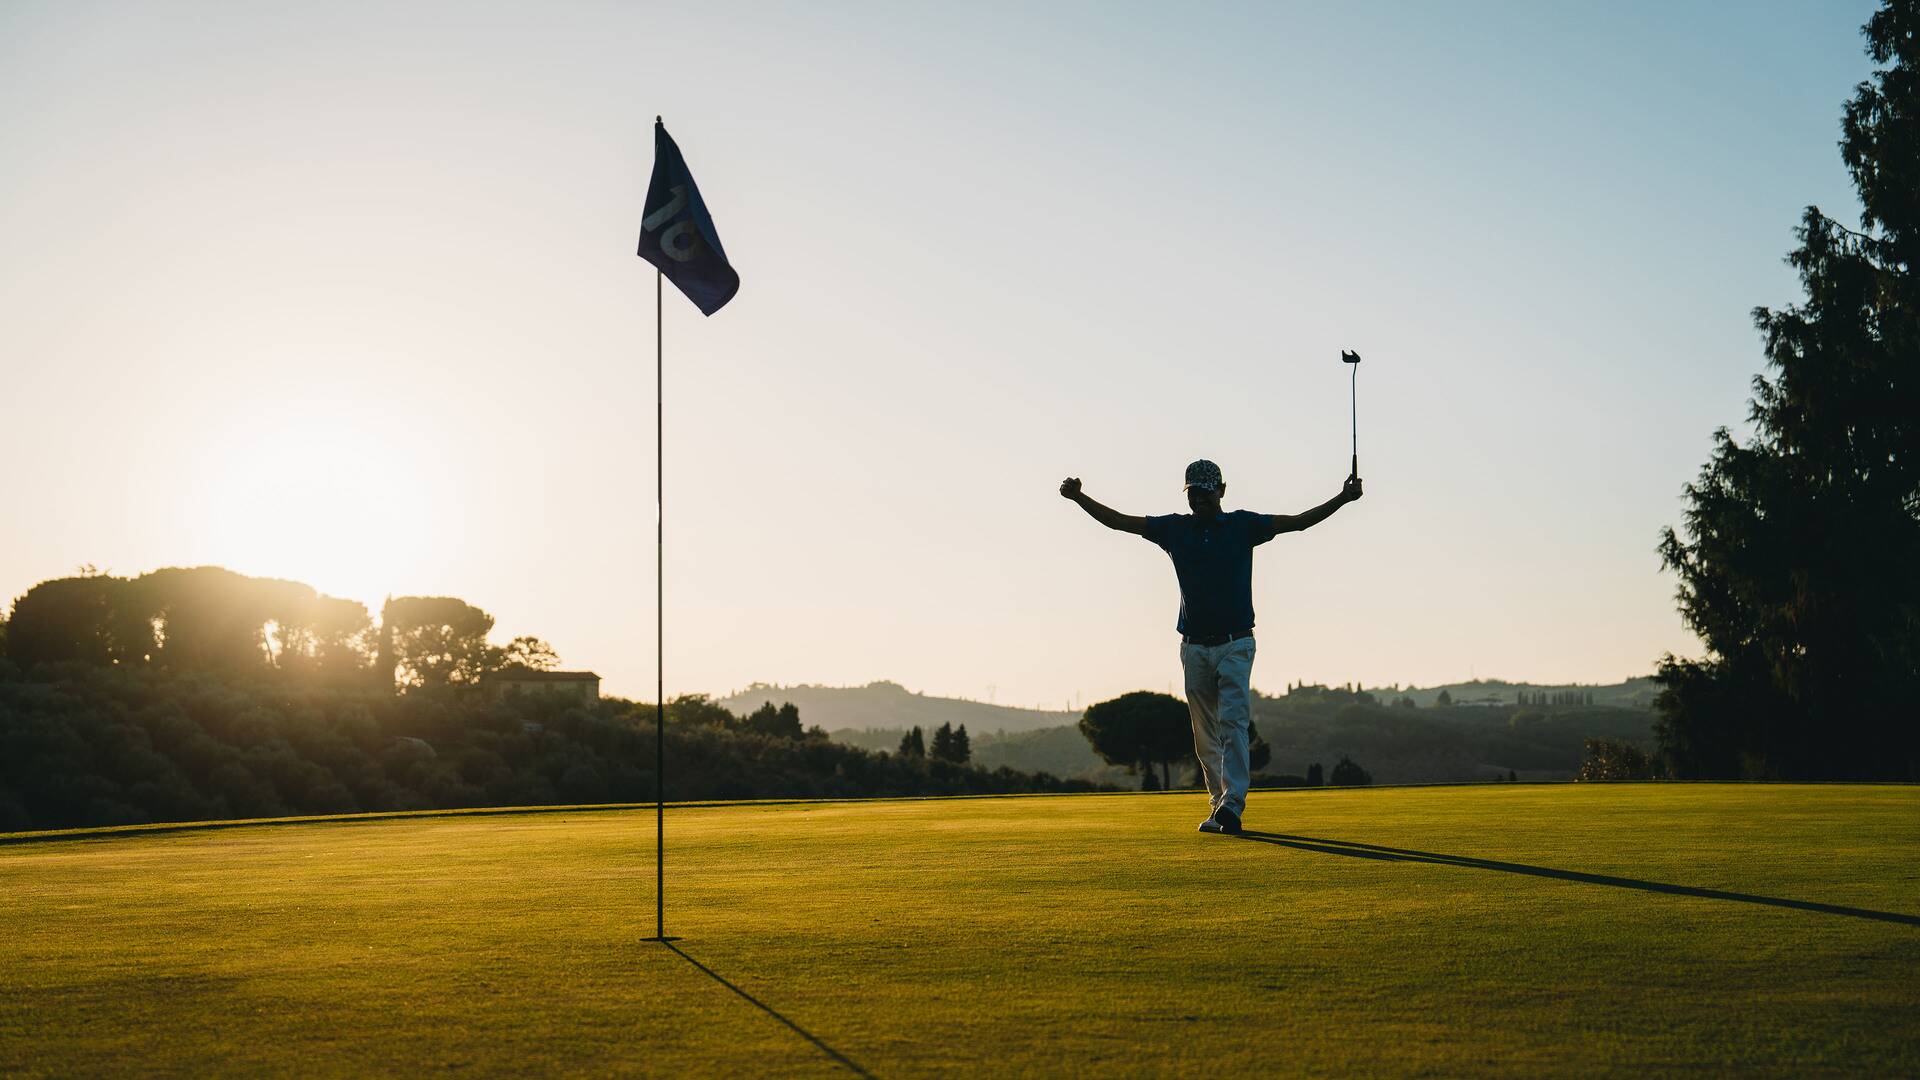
[0,659,1110,832]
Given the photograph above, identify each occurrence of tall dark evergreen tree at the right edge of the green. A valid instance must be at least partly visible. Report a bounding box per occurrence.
[1657,0,1920,778]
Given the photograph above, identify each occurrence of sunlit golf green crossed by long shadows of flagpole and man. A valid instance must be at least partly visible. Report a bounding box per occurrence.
[0,786,1920,1076]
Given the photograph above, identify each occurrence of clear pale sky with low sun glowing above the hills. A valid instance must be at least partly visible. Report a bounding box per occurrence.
[0,0,1874,707]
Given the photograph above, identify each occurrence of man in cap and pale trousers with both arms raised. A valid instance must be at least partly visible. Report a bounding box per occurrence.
[1060,461,1359,834]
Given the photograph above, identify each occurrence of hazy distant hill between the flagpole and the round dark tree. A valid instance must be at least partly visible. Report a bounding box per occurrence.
[718,682,1079,730]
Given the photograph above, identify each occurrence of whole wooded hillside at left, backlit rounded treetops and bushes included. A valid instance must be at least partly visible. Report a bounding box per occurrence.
[0,567,1106,832]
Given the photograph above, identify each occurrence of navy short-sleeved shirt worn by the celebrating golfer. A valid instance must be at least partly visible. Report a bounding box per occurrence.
[1140,509,1273,638]
